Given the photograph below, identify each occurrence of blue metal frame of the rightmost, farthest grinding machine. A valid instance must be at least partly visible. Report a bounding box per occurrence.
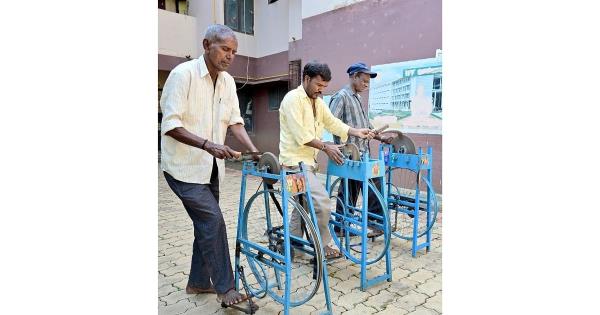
[379,144,437,257]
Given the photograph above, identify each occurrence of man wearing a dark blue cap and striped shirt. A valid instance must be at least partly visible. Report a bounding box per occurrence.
[329,62,392,236]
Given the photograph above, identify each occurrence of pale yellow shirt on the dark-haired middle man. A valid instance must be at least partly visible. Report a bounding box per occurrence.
[279,85,350,166]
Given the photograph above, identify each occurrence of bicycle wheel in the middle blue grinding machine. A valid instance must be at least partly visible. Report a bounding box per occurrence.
[329,177,391,265]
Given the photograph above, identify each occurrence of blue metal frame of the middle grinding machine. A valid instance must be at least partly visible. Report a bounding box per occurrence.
[325,152,392,291]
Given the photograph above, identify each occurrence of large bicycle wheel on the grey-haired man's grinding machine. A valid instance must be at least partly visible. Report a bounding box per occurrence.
[239,190,323,307]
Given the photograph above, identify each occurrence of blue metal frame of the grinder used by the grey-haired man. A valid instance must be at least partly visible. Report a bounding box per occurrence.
[235,161,333,315]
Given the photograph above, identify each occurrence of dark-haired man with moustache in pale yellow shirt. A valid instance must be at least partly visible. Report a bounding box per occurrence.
[279,61,374,259]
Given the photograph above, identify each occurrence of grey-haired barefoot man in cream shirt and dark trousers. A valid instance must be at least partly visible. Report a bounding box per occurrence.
[160,24,258,310]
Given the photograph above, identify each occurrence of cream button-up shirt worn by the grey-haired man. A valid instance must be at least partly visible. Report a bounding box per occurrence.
[160,56,244,184]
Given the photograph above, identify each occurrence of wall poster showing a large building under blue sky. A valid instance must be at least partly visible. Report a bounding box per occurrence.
[369,53,442,134]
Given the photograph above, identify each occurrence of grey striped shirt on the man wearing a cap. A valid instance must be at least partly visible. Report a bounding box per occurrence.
[329,85,373,151]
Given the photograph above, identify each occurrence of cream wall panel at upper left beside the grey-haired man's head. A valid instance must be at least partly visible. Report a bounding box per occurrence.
[158,9,198,58]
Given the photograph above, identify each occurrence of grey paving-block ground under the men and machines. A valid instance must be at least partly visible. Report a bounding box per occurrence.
[158,167,442,315]
